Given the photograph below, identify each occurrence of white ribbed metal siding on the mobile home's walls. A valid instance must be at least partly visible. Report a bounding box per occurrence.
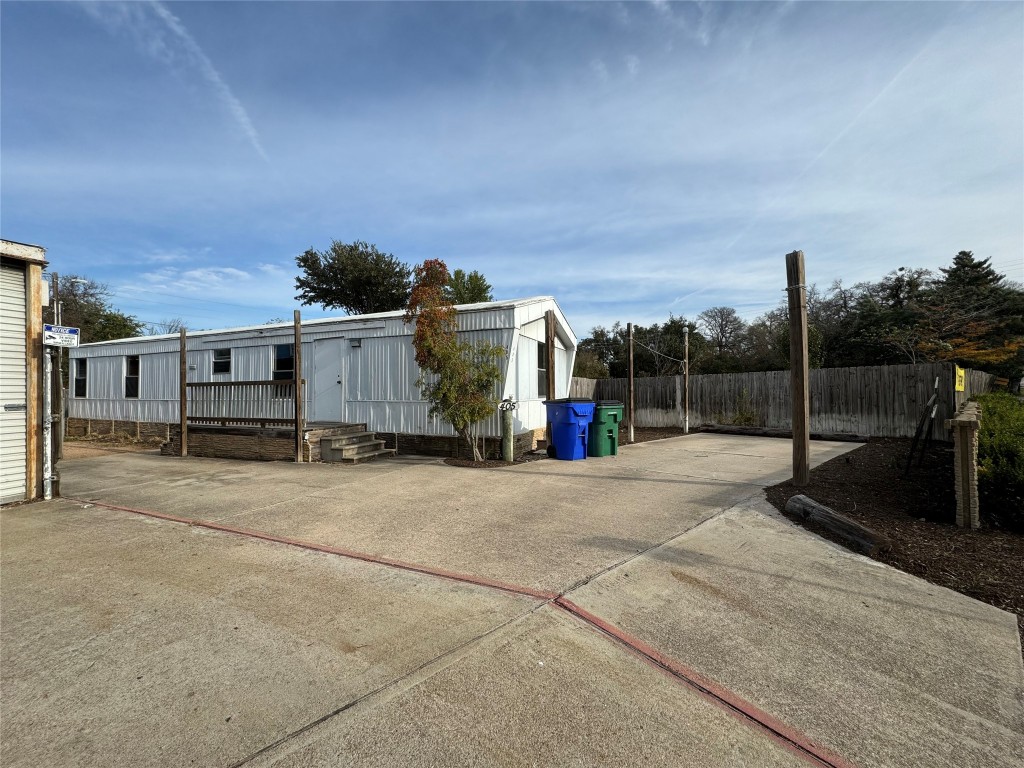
[70,299,575,435]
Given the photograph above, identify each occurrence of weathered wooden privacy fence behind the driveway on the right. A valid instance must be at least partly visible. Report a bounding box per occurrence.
[570,362,993,440]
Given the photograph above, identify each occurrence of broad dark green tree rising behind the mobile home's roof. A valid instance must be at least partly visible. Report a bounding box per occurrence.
[295,240,413,314]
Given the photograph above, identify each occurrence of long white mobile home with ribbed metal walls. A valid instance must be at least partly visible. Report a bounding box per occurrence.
[69,296,577,450]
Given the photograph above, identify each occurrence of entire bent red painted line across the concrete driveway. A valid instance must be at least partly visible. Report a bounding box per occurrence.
[72,497,856,768]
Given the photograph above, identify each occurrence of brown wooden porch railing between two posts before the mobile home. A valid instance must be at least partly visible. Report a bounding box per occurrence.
[185,380,296,427]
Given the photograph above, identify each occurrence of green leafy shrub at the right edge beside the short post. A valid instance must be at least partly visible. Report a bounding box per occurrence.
[978,392,1024,532]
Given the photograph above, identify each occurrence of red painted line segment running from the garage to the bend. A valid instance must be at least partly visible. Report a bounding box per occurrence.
[63,497,558,601]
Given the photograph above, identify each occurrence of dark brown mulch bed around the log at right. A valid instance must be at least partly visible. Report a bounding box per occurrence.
[766,439,1024,633]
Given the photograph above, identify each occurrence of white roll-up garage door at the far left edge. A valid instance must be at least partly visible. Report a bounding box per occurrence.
[0,264,29,504]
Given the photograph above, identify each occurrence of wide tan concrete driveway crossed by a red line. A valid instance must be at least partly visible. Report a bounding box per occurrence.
[6,434,1024,766]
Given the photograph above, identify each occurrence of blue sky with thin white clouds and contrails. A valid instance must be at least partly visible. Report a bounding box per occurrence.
[0,2,1024,336]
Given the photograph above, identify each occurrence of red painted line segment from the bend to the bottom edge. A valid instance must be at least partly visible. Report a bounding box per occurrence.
[554,597,855,768]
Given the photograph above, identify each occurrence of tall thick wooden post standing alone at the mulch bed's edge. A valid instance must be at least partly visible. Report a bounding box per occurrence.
[785,251,811,487]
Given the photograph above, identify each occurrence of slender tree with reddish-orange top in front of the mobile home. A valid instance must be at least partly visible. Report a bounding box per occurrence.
[404,259,505,461]
